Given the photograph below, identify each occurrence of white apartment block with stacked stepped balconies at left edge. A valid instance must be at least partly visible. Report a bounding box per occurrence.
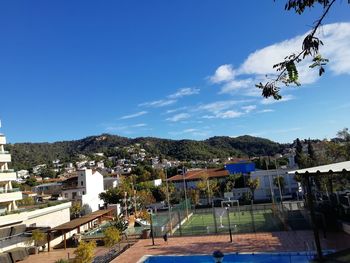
[0,134,22,214]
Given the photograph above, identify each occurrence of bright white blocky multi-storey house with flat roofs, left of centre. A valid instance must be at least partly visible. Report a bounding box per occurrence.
[62,169,104,213]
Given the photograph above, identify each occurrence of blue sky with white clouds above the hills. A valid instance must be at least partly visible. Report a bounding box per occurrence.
[0,0,350,143]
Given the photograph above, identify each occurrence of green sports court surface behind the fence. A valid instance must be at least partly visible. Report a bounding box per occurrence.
[174,210,283,235]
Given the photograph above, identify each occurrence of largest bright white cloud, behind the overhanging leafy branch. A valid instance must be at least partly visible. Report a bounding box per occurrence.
[210,22,350,97]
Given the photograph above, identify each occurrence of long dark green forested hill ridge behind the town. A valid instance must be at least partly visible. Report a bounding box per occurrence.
[6,134,285,169]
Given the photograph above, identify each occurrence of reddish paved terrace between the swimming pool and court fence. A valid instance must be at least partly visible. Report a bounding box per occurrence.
[112,231,350,263]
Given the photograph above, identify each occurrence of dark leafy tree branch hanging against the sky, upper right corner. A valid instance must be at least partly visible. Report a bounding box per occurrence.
[255,0,335,100]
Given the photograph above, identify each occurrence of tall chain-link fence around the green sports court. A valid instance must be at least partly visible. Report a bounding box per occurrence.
[152,201,310,237]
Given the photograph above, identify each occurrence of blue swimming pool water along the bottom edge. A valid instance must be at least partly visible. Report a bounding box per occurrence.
[141,252,313,263]
